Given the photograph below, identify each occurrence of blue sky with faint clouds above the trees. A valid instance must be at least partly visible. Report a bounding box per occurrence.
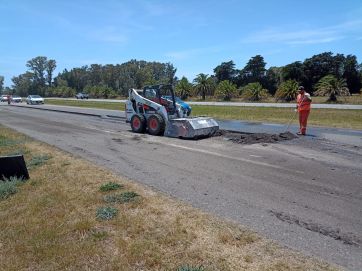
[0,0,362,86]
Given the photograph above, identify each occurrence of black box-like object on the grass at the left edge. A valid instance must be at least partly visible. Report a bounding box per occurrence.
[0,155,29,180]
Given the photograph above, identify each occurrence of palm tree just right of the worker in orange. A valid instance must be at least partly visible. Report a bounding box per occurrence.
[316,75,349,102]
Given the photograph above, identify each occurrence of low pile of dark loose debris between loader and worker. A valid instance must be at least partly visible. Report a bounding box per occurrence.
[214,130,298,144]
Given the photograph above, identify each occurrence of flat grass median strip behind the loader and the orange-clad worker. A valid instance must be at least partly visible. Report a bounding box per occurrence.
[48,99,362,129]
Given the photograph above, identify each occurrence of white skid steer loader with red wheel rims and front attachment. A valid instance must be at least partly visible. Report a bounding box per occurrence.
[125,85,219,138]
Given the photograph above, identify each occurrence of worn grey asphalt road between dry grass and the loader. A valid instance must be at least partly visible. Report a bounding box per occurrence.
[0,105,362,270]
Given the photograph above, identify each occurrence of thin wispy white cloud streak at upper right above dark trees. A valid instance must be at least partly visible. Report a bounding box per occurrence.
[242,20,362,45]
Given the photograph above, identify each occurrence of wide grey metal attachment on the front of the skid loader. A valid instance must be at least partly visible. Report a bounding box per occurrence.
[165,117,219,138]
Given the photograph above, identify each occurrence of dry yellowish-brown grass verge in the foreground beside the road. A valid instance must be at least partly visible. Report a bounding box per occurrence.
[0,126,335,270]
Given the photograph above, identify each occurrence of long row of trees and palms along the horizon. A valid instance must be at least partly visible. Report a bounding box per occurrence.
[0,52,362,101]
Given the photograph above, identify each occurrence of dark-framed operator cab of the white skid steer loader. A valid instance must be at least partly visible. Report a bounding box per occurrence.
[143,85,176,115]
